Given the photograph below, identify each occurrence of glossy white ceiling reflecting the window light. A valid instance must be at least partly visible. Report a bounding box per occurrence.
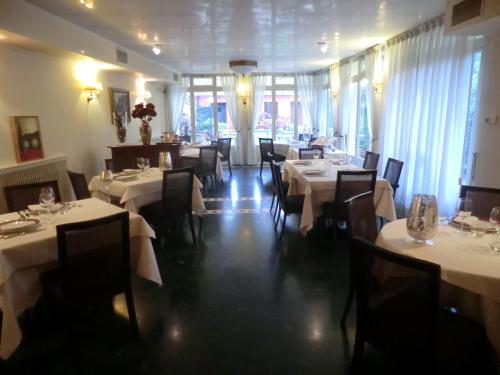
[27,0,445,73]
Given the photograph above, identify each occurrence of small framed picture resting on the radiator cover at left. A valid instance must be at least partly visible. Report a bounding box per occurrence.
[10,116,43,163]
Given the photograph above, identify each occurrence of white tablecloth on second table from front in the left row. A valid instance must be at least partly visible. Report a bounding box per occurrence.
[89,168,205,216]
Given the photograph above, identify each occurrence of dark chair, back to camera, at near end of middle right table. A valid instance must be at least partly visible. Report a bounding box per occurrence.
[323,170,377,229]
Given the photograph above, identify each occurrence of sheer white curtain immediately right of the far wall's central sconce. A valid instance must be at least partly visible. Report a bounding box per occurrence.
[247,75,266,165]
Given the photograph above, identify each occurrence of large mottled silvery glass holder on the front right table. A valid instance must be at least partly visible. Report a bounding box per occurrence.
[406,194,438,246]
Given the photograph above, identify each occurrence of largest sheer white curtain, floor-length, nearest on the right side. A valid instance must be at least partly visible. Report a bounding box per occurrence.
[381,26,474,215]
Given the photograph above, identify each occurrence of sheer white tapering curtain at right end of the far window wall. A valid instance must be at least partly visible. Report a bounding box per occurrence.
[295,73,328,137]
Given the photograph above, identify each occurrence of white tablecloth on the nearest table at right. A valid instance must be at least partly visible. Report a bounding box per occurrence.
[377,219,500,359]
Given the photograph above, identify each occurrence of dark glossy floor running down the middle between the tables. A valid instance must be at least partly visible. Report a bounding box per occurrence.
[2,168,388,374]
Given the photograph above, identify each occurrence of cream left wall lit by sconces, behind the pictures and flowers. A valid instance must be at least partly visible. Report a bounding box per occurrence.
[0,45,166,177]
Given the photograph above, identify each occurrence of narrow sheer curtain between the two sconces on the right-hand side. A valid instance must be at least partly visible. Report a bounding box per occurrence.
[337,63,357,155]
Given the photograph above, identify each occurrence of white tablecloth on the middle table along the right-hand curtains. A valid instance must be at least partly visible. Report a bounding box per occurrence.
[283,159,396,233]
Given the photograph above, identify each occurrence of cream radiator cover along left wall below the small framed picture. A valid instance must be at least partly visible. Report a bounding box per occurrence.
[0,156,72,213]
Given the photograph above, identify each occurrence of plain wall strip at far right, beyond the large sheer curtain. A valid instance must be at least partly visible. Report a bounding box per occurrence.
[472,35,500,188]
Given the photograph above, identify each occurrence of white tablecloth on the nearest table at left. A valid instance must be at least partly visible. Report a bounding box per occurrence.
[0,198,162,358]
